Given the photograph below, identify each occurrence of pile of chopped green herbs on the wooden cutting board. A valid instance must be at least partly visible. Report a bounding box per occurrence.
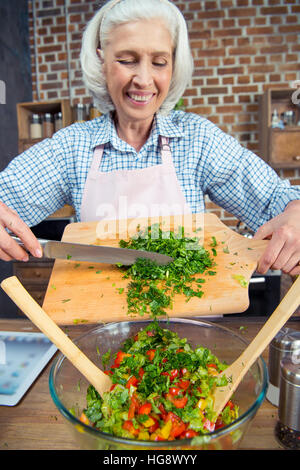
[119,224,217,318]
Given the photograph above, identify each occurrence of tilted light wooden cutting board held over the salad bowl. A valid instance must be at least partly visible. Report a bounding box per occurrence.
[43,214,268,325]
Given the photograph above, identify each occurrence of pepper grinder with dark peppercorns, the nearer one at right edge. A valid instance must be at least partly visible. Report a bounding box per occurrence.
[275,356,300,450]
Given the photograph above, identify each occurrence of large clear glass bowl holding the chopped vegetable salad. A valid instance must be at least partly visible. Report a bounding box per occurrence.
[49,318,268,451]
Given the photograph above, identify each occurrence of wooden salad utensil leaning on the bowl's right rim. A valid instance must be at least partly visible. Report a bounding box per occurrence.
[214,276,300,419]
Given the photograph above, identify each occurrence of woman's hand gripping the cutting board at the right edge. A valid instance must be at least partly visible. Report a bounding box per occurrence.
[254,200,300,276]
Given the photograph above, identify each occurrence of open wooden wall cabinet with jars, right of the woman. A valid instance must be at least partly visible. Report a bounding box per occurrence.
[258,88,300,169]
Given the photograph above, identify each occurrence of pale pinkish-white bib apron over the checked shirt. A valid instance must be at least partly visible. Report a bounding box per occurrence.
[81,137,191,226]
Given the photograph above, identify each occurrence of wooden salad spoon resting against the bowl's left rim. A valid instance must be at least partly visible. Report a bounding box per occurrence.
[1,276,112,397]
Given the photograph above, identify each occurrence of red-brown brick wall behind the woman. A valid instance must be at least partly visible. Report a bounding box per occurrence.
[29,0,300,226]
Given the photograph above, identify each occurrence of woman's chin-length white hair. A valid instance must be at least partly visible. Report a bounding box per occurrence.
[80,0,193,114]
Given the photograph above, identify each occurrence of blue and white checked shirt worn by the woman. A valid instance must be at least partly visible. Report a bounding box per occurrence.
[0,111,300,230]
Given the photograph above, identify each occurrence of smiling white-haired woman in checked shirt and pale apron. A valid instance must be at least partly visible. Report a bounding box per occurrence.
[0,0,300,275]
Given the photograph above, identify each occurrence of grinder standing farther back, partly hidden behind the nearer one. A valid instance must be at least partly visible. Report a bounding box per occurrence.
[266,327,300,406]
